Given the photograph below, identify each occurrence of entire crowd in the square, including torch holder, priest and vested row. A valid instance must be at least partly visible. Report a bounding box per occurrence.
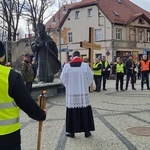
[0,37,150,150]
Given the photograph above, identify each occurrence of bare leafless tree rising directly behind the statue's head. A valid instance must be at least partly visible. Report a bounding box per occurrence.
[23,0,55,36]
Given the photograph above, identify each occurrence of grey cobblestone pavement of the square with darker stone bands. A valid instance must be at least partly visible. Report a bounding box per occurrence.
[21,80,150,150]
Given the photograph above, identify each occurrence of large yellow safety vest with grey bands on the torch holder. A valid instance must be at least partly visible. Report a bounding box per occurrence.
[0,65,20,135]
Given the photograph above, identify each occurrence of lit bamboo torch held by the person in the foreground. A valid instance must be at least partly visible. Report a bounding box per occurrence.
[37,91,46,150]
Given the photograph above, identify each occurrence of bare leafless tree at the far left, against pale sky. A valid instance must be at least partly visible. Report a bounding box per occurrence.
[0,0,25,41]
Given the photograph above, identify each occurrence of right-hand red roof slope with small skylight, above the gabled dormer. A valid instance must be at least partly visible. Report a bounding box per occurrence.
[99,0,150,24]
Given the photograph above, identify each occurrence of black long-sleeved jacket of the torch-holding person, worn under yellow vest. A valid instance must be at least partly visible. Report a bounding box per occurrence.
[0,70,46,150]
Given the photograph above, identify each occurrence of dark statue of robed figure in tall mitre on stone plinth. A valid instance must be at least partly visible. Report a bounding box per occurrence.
[31,23,61,82]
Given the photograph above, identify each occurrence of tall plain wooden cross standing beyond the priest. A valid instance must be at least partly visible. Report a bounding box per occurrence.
[80,27,101,91]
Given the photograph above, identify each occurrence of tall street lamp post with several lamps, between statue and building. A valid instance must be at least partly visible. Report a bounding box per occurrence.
[52,1,67,62]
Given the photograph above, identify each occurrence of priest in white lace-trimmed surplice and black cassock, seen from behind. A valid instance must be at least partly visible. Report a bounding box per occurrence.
[60,51,95,137]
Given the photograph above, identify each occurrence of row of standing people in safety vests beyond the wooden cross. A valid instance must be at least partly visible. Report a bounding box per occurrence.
[92,55,150,92]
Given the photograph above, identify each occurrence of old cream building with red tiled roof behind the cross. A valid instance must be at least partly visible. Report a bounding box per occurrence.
[46,0,150,63]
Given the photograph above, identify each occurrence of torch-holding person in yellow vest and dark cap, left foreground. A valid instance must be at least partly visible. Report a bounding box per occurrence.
[0,41,46,150]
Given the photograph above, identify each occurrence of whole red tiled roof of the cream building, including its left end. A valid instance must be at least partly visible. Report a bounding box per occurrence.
[46,0,150,28]
